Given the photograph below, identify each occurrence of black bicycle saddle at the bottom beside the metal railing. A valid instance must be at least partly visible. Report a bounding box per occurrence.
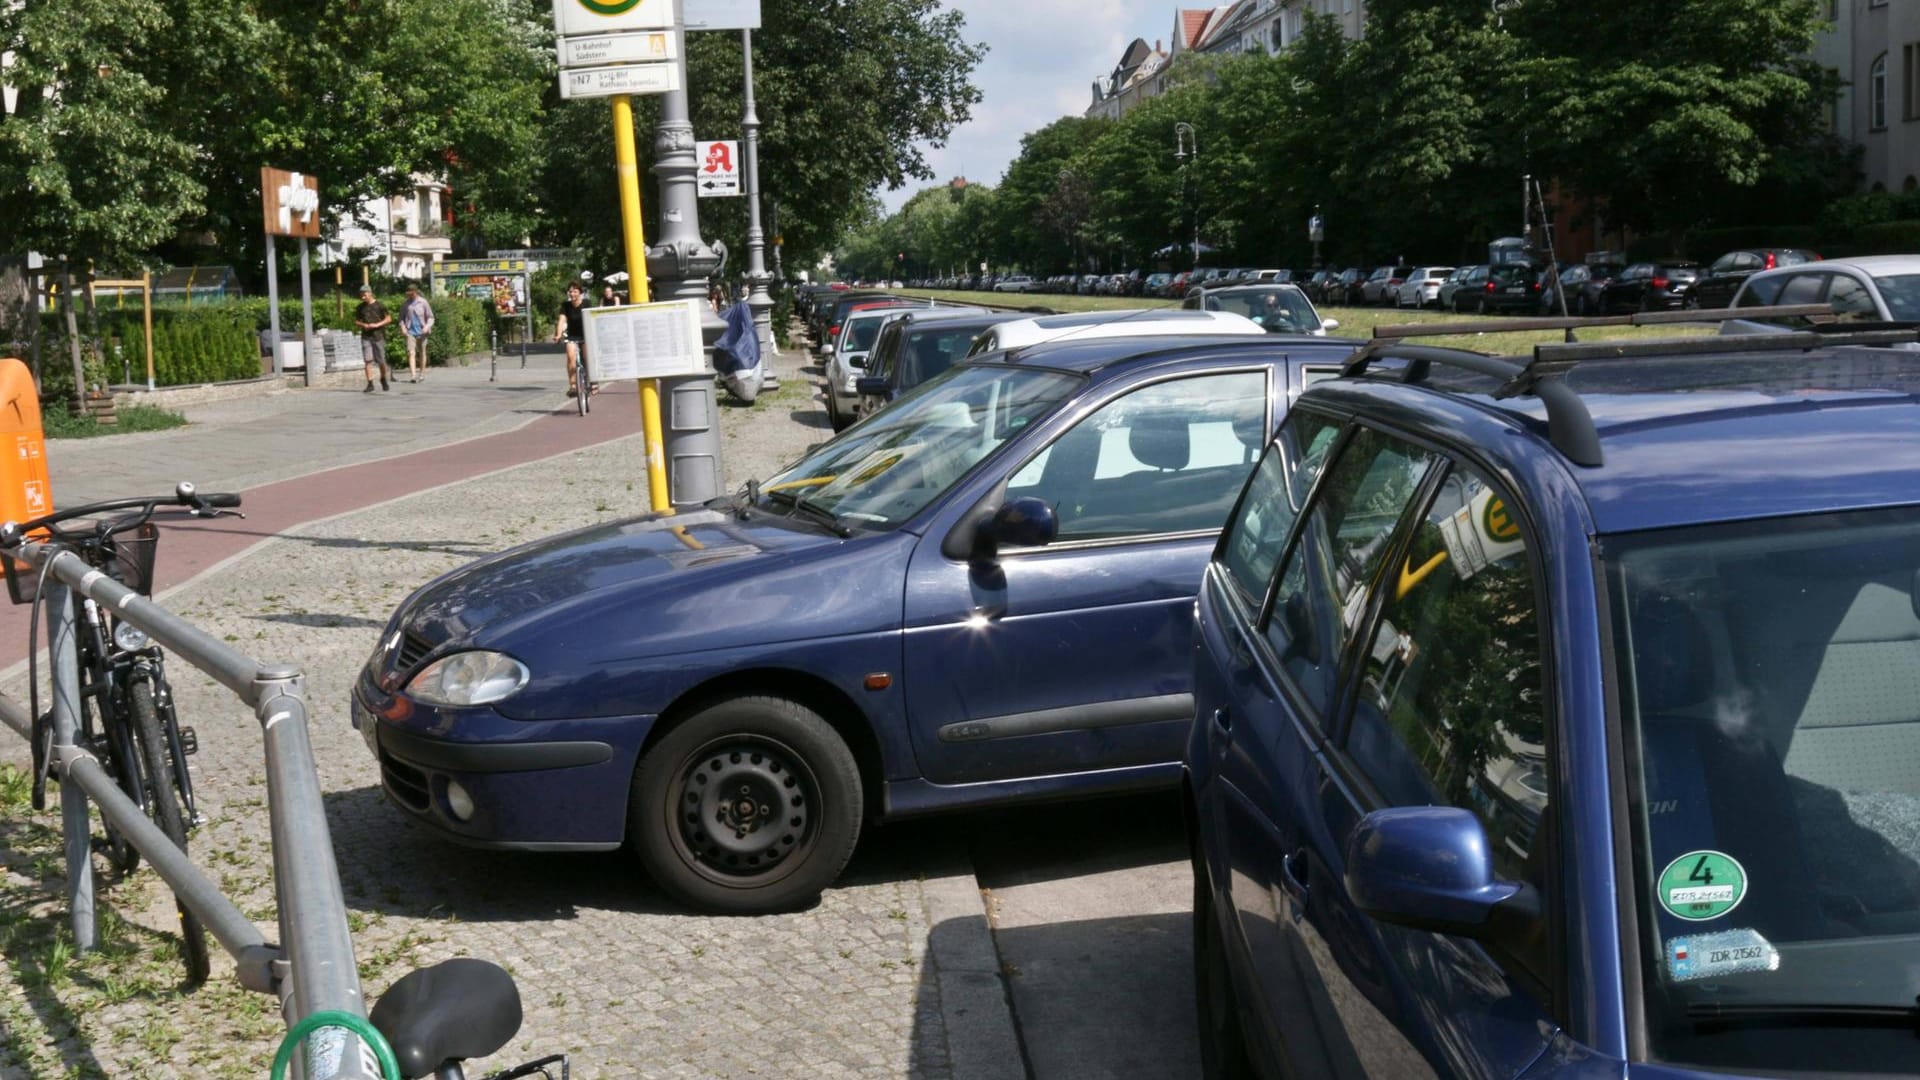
[367,957,520,1080]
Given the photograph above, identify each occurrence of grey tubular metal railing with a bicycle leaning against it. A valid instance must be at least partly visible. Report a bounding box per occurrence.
[0,542,380,1080]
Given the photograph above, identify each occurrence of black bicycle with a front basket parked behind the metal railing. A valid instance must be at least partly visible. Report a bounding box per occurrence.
[0,482,244,982]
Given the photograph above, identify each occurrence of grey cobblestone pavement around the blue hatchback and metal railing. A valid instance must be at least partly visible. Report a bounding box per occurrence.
[0,349,1020,1078]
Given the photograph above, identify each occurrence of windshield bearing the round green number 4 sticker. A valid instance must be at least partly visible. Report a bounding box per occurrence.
[1605,507,1920,1072]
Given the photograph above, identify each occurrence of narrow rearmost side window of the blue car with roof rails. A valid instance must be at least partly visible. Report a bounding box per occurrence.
[1215,409,1340,609]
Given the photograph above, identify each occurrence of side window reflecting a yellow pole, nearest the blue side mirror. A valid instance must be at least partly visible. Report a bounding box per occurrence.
[1346,467,1551,888]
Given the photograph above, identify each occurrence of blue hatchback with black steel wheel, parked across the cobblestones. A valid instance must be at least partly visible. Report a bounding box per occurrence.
[353,336,1352,911]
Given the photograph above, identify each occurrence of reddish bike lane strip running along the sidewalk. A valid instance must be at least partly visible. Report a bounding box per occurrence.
[0,395,643,667]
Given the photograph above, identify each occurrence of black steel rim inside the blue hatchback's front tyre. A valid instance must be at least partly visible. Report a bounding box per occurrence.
[664,734,824,888]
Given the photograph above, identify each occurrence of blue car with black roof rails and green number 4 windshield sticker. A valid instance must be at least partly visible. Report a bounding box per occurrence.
[1185,331,1920,1080]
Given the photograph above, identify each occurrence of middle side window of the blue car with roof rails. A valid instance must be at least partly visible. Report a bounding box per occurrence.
[1265,429,1432,713]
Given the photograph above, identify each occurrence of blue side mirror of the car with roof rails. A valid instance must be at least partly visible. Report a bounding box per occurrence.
[1346,807,1544,942]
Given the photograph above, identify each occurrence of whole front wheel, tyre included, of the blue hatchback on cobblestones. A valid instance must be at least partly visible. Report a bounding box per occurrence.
[628,698,862,915]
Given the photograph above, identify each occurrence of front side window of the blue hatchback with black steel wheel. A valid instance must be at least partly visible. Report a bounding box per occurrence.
[1006,371,1267,542]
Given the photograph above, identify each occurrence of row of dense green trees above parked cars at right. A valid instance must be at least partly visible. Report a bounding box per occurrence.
[841,0,1835,277]
